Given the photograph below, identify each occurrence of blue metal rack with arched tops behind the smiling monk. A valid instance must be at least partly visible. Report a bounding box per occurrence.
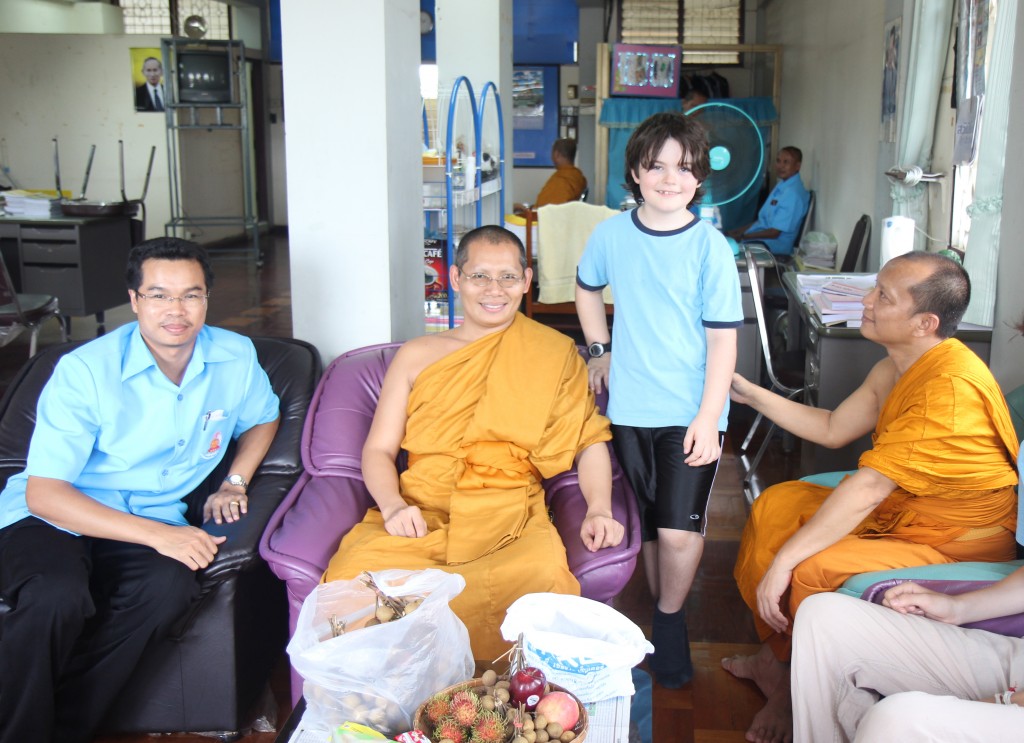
[423,76,505,327]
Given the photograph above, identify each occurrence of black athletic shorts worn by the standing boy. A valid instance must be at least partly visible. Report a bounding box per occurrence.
[611,424,724,541]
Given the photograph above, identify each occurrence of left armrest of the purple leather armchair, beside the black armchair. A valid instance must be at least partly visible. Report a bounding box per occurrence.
[259,473,374,583]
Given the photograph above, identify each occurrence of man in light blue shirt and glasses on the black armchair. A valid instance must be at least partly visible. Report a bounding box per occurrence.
[0,237,280,743]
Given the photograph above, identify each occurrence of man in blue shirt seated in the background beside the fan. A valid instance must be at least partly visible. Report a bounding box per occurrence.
[728,147,811,256]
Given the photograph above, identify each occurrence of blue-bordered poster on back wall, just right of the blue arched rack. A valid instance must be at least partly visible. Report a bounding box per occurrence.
[512,64,559,168]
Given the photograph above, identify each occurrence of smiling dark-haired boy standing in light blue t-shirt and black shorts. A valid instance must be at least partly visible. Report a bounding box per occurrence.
[575,113,743,688]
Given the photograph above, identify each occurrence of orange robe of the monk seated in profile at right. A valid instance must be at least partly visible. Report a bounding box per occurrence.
[733,339,1018,660]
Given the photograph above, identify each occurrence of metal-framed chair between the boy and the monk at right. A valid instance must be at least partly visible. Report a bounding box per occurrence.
[739,245,807,504]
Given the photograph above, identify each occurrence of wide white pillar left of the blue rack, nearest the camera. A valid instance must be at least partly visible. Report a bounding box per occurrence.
[281,0,423,361]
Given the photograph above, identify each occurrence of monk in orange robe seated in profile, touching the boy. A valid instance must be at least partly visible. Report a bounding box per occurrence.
[722,252,1018,742]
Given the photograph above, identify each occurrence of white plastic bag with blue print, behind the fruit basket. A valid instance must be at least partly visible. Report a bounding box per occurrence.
[502,594,654,704]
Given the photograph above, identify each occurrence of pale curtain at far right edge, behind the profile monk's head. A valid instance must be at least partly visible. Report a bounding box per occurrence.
[964,0,1024,326]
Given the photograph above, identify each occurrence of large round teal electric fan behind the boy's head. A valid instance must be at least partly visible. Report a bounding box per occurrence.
[687,101,765,253]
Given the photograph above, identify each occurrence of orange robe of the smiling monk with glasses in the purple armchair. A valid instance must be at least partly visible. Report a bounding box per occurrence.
[324,315,611,660]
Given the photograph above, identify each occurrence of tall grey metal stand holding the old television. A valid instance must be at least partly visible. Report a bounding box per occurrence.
[161,37,263,266]
